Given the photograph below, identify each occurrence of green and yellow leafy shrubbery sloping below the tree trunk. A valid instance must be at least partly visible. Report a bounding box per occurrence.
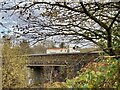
[66,59,118,88]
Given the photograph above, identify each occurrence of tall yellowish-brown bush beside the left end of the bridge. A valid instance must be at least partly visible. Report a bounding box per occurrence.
[2,38,27,88]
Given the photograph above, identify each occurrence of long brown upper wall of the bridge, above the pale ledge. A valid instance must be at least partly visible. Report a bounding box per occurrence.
[28,53,98,65]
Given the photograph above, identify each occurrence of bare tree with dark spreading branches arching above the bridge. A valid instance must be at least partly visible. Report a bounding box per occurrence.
[1,1,120,55]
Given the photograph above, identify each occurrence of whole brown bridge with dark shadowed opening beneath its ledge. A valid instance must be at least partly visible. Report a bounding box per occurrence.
[27,53,99,84]
